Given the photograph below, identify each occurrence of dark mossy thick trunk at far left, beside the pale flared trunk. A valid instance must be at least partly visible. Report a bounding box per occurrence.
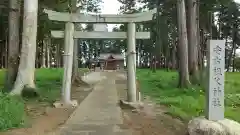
[5,0,21,91]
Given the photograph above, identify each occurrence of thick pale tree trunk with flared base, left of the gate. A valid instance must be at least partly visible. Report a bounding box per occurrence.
[11,0,38,95]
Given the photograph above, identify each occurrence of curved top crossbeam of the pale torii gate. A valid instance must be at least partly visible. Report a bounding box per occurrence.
[44,9,157,24]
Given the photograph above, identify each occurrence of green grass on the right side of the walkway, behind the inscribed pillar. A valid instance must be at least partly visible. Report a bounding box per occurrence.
[137,69,240,122]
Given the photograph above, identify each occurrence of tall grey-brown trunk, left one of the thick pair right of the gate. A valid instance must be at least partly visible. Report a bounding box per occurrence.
[177,0,190,87]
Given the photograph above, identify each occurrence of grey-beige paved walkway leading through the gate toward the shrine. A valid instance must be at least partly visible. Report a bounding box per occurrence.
[61,72,130,135]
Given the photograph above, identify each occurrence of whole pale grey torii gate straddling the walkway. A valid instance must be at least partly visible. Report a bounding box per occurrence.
[44,9,156,104]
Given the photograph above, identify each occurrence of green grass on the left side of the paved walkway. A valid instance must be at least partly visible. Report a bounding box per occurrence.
[0,68,87,130]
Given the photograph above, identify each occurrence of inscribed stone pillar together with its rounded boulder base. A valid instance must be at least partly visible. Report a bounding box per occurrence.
[188,40,240,135]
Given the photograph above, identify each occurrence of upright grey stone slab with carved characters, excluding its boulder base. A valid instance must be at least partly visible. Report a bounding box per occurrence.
[205,40,225,120]
